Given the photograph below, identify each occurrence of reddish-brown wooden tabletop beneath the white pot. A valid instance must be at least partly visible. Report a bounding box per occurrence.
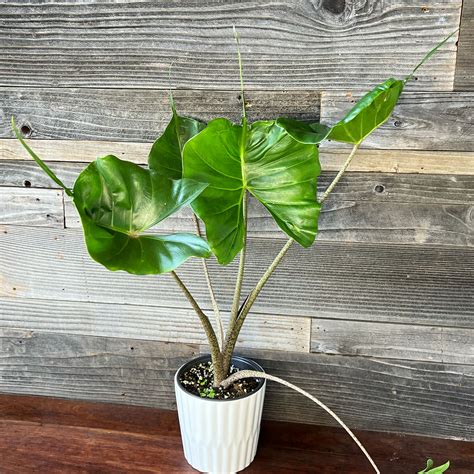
[0,395,474,474]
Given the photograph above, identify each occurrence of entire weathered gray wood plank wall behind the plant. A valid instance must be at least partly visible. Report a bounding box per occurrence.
[0,0,474,439]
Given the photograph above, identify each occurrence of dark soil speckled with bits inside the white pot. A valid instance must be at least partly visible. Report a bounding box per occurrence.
[180,361,259,400]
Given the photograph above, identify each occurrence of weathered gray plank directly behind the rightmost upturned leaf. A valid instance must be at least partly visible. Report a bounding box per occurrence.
[321,89,474,151]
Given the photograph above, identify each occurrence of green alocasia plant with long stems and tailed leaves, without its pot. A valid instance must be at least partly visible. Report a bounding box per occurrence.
[13,33,454,472]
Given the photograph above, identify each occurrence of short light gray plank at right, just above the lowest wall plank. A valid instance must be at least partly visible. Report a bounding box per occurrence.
[311,318,474,365]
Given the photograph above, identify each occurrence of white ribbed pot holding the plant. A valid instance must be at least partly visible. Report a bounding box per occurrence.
[174,356,266,474]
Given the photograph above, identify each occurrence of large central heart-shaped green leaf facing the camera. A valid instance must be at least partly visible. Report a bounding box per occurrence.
[183,118,320,264]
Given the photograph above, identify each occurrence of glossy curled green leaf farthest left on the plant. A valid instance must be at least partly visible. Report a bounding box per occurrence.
[73,156,210,275]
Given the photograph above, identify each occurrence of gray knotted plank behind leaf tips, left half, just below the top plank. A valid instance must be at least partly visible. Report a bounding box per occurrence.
[0,88,320,141]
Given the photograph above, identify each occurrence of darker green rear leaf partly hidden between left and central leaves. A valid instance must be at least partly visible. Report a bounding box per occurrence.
[148,101,206,179]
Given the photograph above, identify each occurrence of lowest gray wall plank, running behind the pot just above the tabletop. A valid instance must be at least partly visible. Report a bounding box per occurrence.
[0,329,474,439]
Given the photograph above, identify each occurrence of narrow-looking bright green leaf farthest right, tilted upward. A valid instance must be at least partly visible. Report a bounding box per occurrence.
[327,79,405,144]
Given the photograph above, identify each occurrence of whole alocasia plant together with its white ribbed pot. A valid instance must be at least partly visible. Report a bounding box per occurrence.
[12,33,454,473]
